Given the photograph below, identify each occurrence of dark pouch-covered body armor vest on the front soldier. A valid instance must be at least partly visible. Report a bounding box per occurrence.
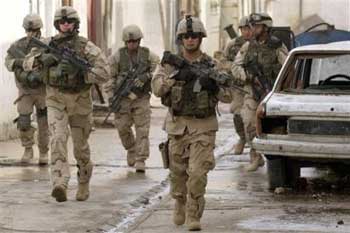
[162,56,218,118]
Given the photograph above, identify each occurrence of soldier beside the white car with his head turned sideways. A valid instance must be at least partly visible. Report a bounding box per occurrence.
[232,13,288,172]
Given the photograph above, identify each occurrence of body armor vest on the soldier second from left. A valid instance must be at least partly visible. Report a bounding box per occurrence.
[44,35,91,93]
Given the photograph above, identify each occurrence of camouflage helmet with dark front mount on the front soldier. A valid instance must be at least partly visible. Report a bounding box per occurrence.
[176,15,207,39]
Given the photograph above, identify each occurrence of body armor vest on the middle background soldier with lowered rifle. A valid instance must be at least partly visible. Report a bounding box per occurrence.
[119,47,151,97]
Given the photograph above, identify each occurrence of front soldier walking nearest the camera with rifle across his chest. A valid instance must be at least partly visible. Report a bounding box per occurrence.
[152,16,231,230]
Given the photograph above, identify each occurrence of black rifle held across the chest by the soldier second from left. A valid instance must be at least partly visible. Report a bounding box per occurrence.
[29,37,105,104]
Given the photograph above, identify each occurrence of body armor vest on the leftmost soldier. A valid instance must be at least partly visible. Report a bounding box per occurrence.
[14,37,44,89]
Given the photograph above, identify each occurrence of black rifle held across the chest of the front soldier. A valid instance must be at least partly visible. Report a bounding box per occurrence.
[161,51,248,94]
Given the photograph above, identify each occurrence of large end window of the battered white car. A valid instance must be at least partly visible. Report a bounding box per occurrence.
[281,54,350,94]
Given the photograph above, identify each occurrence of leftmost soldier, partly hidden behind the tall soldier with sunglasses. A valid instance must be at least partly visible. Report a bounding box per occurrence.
[5,14,49,165]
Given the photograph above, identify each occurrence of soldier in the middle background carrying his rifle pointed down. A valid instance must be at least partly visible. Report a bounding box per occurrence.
[107,25,159,172]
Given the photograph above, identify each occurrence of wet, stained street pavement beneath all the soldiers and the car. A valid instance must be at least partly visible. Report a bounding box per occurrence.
[0,106,350,233]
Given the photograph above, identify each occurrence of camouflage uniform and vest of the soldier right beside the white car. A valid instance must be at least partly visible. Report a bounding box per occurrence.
[232,12,288,171]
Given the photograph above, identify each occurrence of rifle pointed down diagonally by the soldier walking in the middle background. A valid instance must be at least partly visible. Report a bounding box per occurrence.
[103,64,150,124]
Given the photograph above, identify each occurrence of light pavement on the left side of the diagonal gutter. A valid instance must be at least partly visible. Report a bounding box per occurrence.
[0,105,238,233]
